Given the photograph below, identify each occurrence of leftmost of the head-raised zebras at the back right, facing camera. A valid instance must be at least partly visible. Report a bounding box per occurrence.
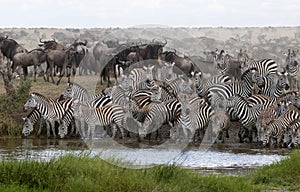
[214,50,242,80]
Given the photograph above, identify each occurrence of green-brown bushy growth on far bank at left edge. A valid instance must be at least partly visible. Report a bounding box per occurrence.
[0,80,31,136]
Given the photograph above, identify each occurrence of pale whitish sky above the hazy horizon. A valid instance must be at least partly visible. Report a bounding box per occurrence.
[0,0,300,28]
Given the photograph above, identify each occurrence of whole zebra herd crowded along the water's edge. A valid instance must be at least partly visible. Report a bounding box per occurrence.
[22,48,300,147]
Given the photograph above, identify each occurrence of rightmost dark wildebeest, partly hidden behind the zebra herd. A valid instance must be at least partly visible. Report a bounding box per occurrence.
[160,51,200,77]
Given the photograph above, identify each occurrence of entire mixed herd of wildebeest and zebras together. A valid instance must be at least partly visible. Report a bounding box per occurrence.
[0,34,300,147]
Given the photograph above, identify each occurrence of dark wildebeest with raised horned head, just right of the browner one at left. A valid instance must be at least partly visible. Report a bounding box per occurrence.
[44,41,87,85]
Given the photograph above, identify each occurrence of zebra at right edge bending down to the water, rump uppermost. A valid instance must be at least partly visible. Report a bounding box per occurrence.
[263,108,299,146]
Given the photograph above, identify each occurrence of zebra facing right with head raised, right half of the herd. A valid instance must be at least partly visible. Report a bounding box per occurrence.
[208,69,262,99]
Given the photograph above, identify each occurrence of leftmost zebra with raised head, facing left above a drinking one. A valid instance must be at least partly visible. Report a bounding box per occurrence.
[24,92,73,137]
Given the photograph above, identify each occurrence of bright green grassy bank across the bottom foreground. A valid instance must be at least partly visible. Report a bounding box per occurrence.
[0,150,300,192]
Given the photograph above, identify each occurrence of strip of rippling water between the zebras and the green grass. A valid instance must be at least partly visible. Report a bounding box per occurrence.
[0,138,290,175]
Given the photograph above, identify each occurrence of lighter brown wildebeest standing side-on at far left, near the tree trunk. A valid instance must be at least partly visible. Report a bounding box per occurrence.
[12,49,47,81]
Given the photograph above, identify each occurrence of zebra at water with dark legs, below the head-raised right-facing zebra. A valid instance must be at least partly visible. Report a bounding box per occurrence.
[226,95,263,142]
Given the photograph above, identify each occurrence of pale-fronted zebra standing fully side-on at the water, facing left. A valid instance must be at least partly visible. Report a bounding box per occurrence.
[73,100,125,139]
